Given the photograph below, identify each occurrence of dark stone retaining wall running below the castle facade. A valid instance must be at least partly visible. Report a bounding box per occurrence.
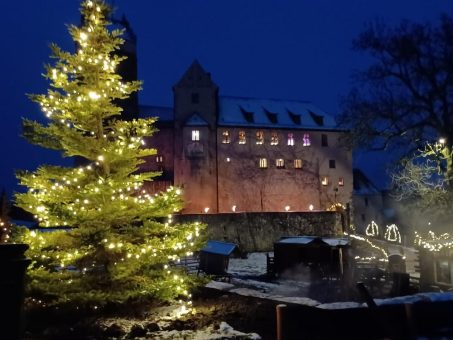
[175,211,345,252]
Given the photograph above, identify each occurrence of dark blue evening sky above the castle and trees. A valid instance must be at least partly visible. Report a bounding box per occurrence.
[0,0,453,197]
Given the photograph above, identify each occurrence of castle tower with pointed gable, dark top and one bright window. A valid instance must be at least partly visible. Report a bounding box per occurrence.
[173,61,218,213]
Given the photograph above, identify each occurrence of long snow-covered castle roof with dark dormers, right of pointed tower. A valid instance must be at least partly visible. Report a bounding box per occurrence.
[218,96,338,130]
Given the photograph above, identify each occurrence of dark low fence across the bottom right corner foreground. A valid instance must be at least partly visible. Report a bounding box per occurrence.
[276,301,453,340]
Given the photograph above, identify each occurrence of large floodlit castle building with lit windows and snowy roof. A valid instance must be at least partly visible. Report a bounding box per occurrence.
[140,61,353,214]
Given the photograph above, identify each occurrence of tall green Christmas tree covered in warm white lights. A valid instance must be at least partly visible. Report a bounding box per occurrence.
[16,0,202,305]
